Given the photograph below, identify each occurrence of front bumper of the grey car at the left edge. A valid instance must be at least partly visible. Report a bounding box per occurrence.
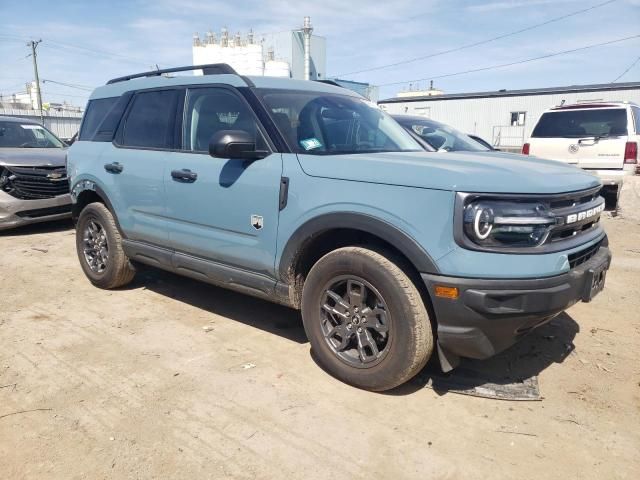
[0,191,71,230]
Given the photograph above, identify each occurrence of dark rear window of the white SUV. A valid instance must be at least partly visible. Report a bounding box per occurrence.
[531,108,627,138]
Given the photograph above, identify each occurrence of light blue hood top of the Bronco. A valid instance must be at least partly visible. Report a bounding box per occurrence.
[298,152,600,194]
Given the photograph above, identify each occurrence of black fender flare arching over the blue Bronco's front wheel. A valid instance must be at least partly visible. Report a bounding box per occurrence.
[278,212,439,283]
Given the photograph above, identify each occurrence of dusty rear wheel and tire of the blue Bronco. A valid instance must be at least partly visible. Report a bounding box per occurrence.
[76,202,136,289]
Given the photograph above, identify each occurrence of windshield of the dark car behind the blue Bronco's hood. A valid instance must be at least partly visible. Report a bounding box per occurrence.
[397,118,489,152]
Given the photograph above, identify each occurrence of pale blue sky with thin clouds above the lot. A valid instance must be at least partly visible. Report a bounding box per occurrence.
[0,0,640,104]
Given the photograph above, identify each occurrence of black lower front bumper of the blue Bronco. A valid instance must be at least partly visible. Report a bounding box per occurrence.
[422,246,611,370]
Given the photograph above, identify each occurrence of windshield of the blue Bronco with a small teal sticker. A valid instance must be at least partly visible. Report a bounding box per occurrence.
[261,90,423,155]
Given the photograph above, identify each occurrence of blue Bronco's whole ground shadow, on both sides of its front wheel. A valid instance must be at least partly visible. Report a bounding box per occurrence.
[124,265,580,396]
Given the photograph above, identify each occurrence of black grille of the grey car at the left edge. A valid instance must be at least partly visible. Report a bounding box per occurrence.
[0,167,69,200]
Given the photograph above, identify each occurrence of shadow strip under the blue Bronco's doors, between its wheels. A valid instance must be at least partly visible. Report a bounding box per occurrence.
[131,266,307,344]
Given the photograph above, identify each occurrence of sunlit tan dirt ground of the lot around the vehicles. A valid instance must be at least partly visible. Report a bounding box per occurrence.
[0,178,640,480]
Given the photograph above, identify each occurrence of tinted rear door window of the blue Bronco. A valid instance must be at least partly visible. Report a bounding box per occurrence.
[122,90,178,149]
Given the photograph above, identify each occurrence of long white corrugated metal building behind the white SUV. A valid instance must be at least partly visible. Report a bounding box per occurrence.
[378,82,640,150]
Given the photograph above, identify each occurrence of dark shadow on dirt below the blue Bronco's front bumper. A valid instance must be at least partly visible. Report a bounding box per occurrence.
[387,312,580,395]
